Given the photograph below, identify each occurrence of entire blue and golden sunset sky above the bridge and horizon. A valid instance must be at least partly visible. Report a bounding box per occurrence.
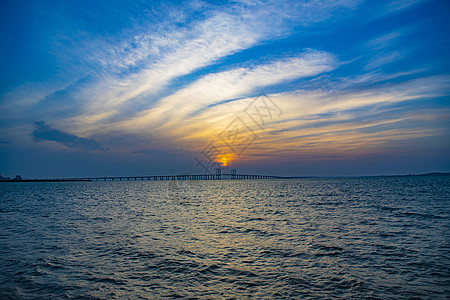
[0,0,450,178]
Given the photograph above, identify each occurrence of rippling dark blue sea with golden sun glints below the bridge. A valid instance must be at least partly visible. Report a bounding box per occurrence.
[0,176,450,299]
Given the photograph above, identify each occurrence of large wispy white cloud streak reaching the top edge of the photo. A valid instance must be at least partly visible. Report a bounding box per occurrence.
[22,0,359,126]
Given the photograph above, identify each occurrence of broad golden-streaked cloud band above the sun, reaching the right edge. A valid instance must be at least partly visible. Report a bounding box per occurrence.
[160,76,450,160]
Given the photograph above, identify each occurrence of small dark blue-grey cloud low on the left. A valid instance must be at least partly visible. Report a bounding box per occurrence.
[32,121,106,151]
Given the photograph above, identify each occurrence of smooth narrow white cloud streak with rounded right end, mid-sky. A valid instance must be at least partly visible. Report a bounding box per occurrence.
[125,50,337,131]
